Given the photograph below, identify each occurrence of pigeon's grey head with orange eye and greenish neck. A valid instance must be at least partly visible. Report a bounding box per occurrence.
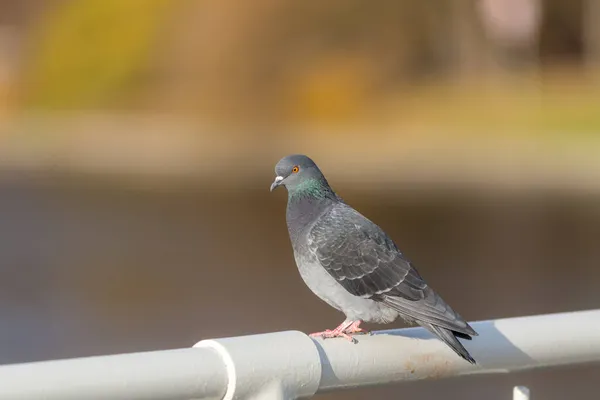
[271,154,332,195]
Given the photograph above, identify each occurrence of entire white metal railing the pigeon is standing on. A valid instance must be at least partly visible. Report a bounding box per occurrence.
[0,310,600,400]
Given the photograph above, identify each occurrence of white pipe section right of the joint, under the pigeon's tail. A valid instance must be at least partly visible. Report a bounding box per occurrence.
[316,310,600,392]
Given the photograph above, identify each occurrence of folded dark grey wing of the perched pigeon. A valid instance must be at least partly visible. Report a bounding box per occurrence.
[308,203,477,335]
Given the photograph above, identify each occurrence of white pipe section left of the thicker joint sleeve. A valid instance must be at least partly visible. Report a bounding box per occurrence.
[0,349,227,400]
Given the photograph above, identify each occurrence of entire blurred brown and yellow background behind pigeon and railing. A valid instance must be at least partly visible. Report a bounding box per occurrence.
[0,0,600,400]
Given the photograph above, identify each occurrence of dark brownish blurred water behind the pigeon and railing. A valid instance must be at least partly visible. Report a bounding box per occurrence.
[0,174,600,400]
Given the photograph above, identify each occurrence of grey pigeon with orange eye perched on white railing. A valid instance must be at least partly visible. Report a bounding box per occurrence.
[270,154,478,364]
